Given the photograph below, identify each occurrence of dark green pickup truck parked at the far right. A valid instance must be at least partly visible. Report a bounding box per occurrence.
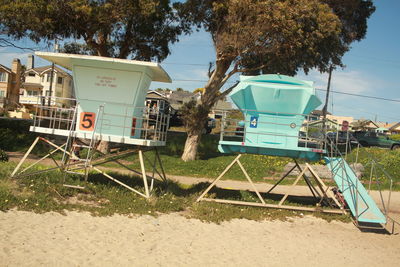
[353,132,400,150]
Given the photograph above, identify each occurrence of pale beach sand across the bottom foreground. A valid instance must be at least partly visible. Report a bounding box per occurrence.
[0,210,400,266]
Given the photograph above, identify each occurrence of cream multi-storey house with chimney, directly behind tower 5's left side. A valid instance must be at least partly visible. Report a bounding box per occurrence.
[20,57,74,107]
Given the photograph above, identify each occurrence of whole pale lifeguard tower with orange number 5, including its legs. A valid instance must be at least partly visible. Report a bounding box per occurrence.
[12,52,171,198]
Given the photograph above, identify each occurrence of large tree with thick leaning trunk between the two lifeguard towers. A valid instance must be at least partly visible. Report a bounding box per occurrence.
[175,0,374,161]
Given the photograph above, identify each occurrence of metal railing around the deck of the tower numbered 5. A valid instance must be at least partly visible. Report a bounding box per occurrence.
[33,96,170,141]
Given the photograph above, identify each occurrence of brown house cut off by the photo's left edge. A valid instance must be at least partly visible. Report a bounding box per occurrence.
[0,58,21,108]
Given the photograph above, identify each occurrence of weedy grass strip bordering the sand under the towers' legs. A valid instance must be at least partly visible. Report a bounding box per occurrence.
[0,163,342,223]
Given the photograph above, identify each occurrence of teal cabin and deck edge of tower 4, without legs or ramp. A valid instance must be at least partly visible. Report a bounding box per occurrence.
[218,75,323,160]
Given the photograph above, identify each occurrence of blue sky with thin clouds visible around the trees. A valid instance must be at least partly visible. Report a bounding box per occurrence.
[0,0,400,122]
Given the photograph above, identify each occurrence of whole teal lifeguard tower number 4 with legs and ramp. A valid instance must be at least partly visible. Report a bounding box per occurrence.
[197,75,390,230]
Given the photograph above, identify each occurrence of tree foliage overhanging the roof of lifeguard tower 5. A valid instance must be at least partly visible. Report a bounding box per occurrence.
[0,0,182,60]
